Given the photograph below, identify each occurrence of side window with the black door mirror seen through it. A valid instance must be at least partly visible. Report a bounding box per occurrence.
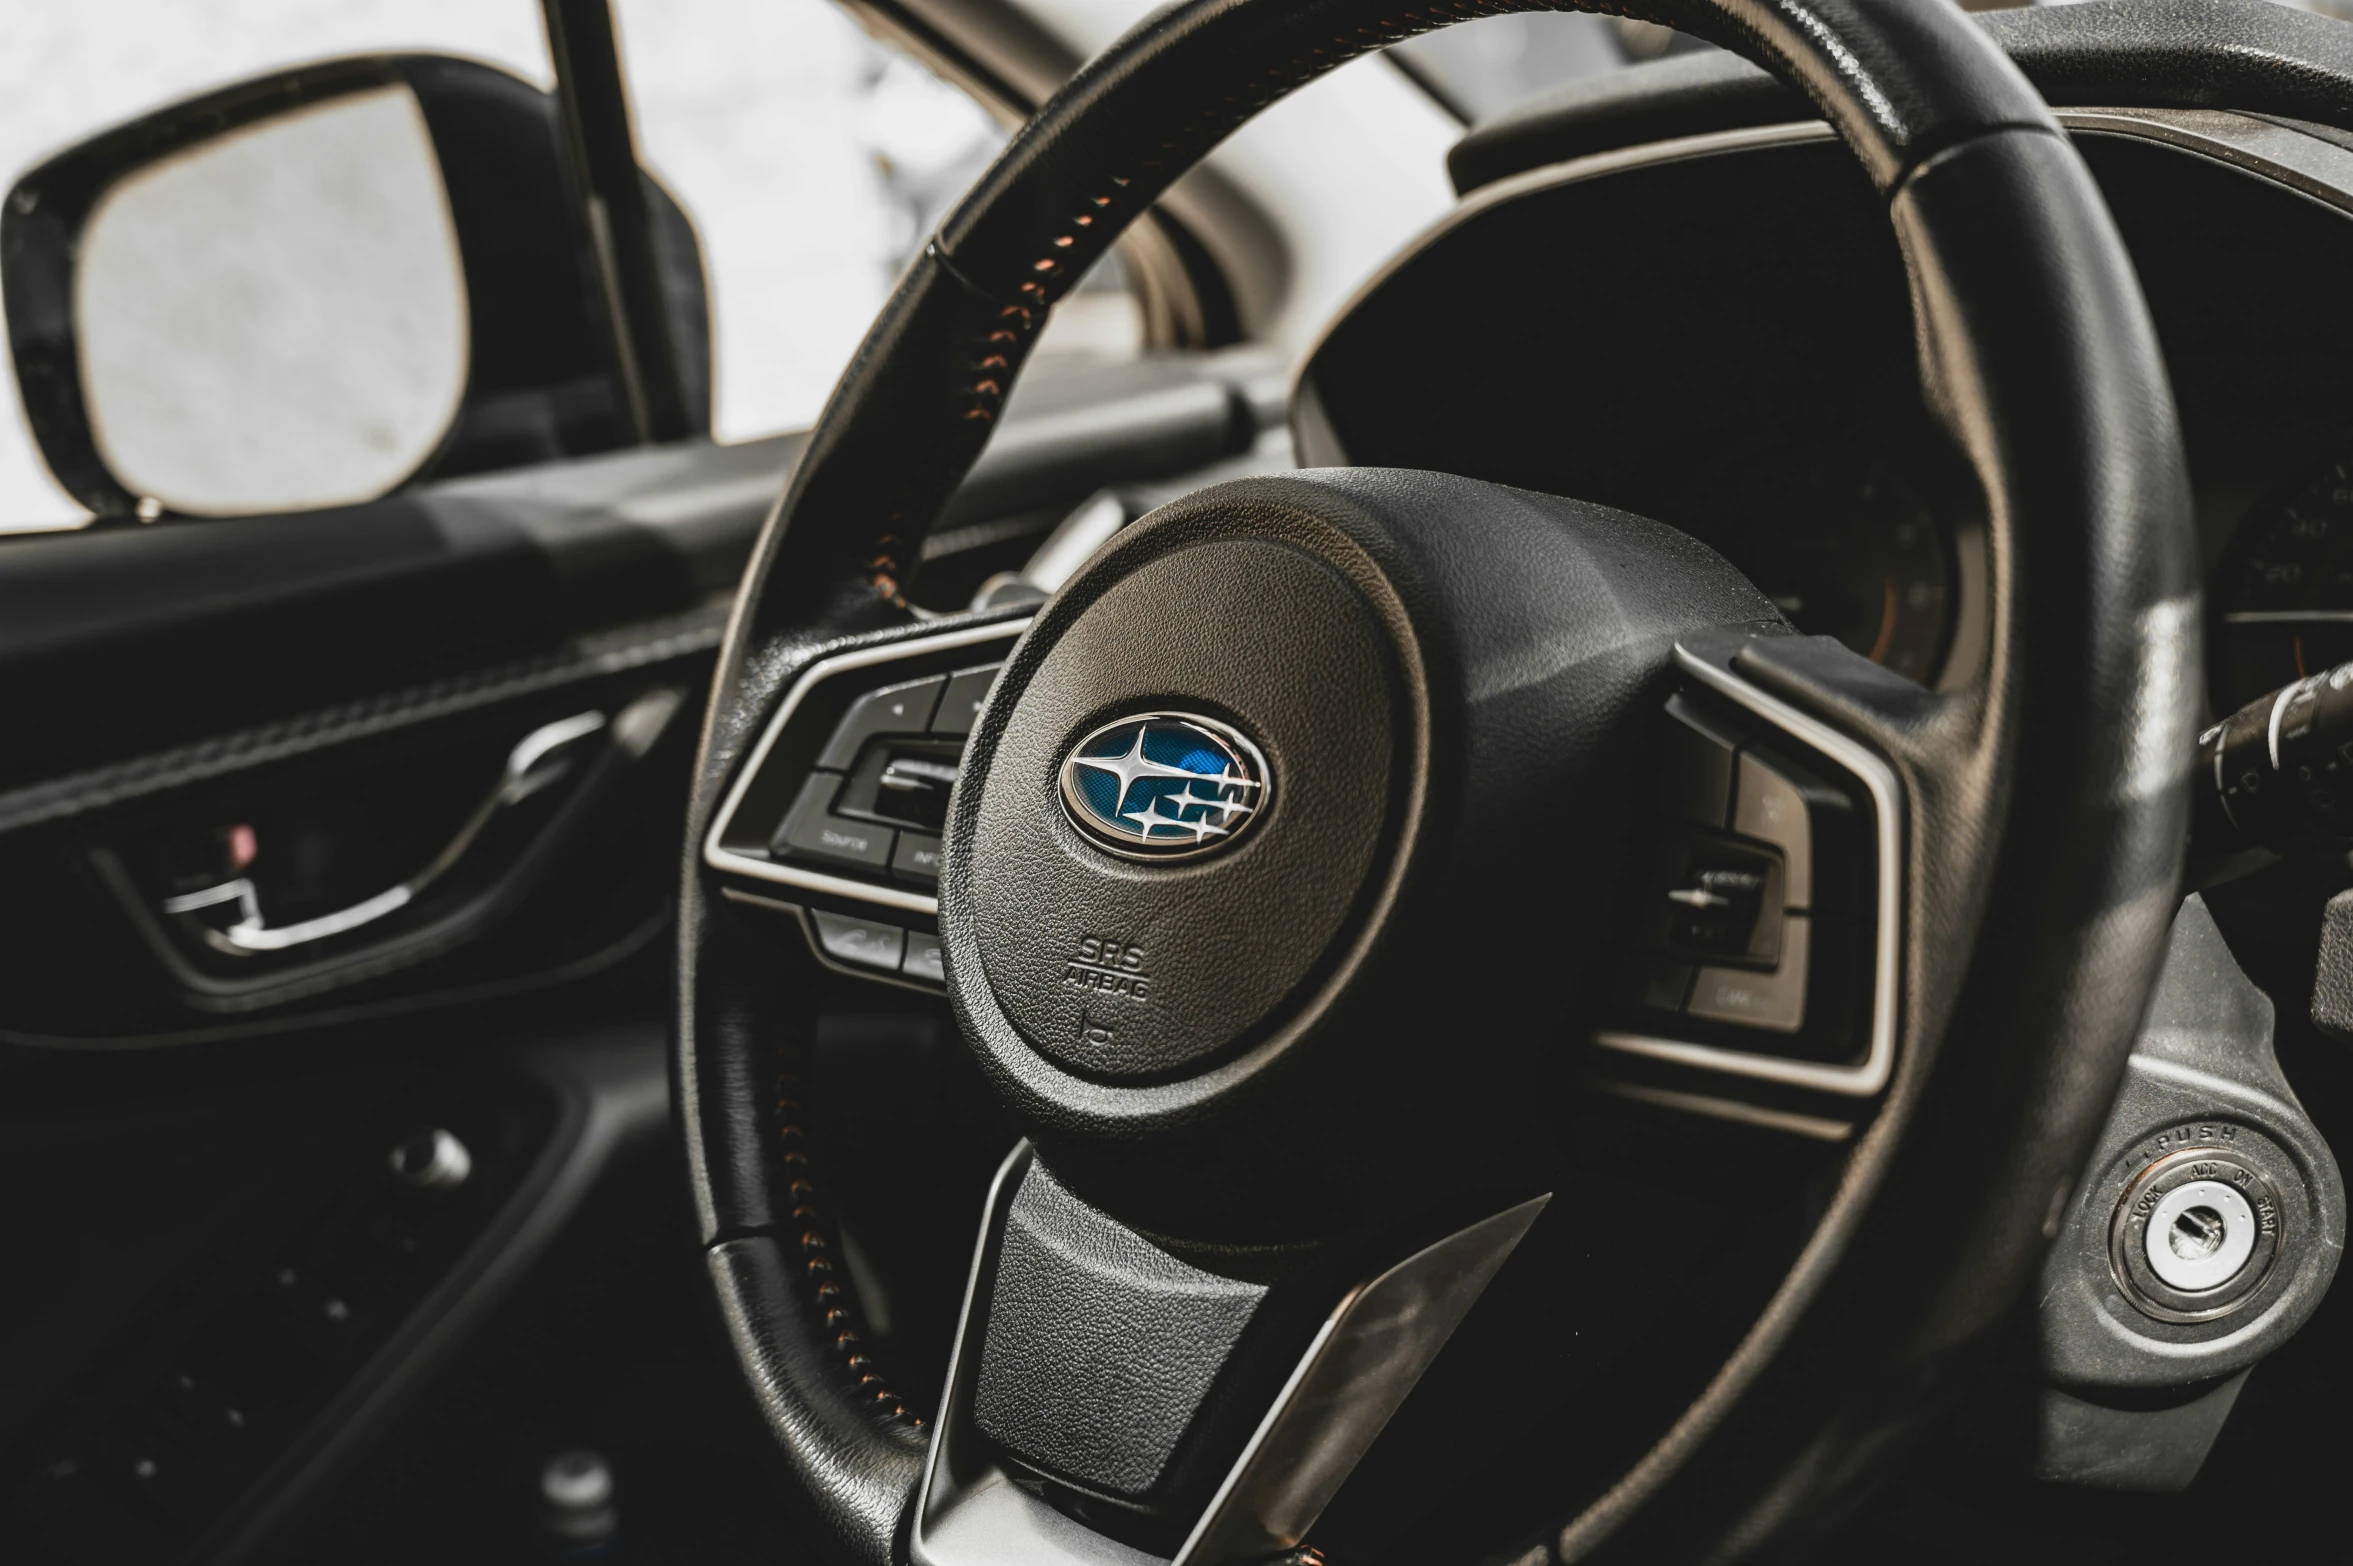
[0,0,1138,531]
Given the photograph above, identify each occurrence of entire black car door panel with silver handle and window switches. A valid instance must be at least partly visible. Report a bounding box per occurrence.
[0,345,1280,1561]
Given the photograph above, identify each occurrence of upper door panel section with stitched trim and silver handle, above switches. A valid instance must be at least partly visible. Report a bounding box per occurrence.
[0,348,1273,1046]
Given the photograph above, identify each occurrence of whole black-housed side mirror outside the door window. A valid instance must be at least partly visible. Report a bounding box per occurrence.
[0,54,711,520]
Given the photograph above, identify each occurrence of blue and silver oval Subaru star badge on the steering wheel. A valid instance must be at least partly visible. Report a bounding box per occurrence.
[1061,712,1273,858]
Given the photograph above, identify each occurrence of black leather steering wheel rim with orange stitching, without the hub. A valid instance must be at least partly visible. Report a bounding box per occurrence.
[675,0,2202,1561]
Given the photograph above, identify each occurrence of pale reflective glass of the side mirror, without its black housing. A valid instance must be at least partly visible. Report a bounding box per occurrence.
[73,82,468,515]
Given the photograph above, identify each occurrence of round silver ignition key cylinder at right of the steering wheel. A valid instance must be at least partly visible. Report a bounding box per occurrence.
[2108,1147,2280,1321]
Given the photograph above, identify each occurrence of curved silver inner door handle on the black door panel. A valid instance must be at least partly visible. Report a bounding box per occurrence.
[162,691,640,957]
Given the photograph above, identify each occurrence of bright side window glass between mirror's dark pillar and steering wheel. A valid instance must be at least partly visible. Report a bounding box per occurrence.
[614,0,1144,440]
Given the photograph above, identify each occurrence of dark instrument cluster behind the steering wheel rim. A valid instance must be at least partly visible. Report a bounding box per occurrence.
[1294,108,2353,712]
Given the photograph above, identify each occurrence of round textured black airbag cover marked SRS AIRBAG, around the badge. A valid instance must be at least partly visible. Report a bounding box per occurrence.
[962,527,1395,1082]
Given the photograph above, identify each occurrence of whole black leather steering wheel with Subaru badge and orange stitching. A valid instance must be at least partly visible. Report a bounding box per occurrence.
[675,0,2200,1566]
